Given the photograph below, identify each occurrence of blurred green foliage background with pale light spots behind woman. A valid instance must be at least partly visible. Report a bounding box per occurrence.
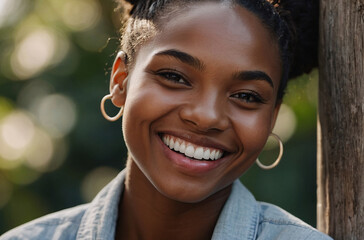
[0,0,318,235]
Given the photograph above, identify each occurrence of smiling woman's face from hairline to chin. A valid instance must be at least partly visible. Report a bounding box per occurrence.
[118,3,281,202]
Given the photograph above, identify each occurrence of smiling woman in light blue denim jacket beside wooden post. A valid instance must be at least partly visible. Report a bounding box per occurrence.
[1,0,330,240]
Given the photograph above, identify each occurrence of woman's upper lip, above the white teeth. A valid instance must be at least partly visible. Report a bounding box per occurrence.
[159,131,233,153]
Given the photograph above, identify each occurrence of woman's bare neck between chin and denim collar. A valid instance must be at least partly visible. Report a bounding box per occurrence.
[116,159,231,240]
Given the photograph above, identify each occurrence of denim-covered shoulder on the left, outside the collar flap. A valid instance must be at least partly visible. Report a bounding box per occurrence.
[0,204,87,240]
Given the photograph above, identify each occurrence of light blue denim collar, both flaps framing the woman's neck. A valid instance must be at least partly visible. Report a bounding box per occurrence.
[76,169,259,240]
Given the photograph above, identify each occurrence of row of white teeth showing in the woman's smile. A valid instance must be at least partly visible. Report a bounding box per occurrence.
[162,135,223,161]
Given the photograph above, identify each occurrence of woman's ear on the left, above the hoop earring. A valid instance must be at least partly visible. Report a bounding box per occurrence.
[110,51,128,107]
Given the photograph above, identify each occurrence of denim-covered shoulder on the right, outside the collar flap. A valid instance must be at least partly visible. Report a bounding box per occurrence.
[257,202,332,240]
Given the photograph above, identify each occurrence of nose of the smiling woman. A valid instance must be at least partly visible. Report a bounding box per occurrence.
[180,94,229,132]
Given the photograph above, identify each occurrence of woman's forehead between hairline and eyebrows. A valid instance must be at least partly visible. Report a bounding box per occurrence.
[135,2,281,84]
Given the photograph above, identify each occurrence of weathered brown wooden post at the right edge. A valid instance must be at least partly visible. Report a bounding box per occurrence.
[317,0,364,240]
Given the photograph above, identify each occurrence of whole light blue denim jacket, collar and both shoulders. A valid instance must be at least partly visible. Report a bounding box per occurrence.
[0,170,331,240]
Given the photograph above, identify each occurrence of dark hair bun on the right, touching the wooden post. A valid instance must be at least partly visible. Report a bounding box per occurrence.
[279,0,319,78]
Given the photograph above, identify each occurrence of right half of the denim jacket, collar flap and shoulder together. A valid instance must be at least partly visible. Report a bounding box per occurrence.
[212,180,331,240]
